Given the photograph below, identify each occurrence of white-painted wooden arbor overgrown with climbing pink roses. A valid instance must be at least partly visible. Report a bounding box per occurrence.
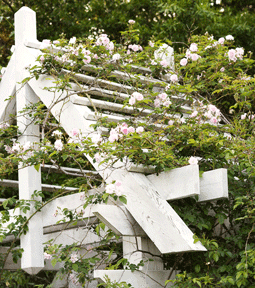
[0,7,228,288]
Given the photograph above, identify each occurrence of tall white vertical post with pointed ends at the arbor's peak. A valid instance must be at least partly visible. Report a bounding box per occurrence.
[15,7,44,274]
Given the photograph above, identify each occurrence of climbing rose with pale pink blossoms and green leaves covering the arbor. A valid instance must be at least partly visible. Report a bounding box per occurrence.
[0,21,255,287]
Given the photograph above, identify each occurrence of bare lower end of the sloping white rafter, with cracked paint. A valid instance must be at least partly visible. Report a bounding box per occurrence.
[100,169,206,254]
